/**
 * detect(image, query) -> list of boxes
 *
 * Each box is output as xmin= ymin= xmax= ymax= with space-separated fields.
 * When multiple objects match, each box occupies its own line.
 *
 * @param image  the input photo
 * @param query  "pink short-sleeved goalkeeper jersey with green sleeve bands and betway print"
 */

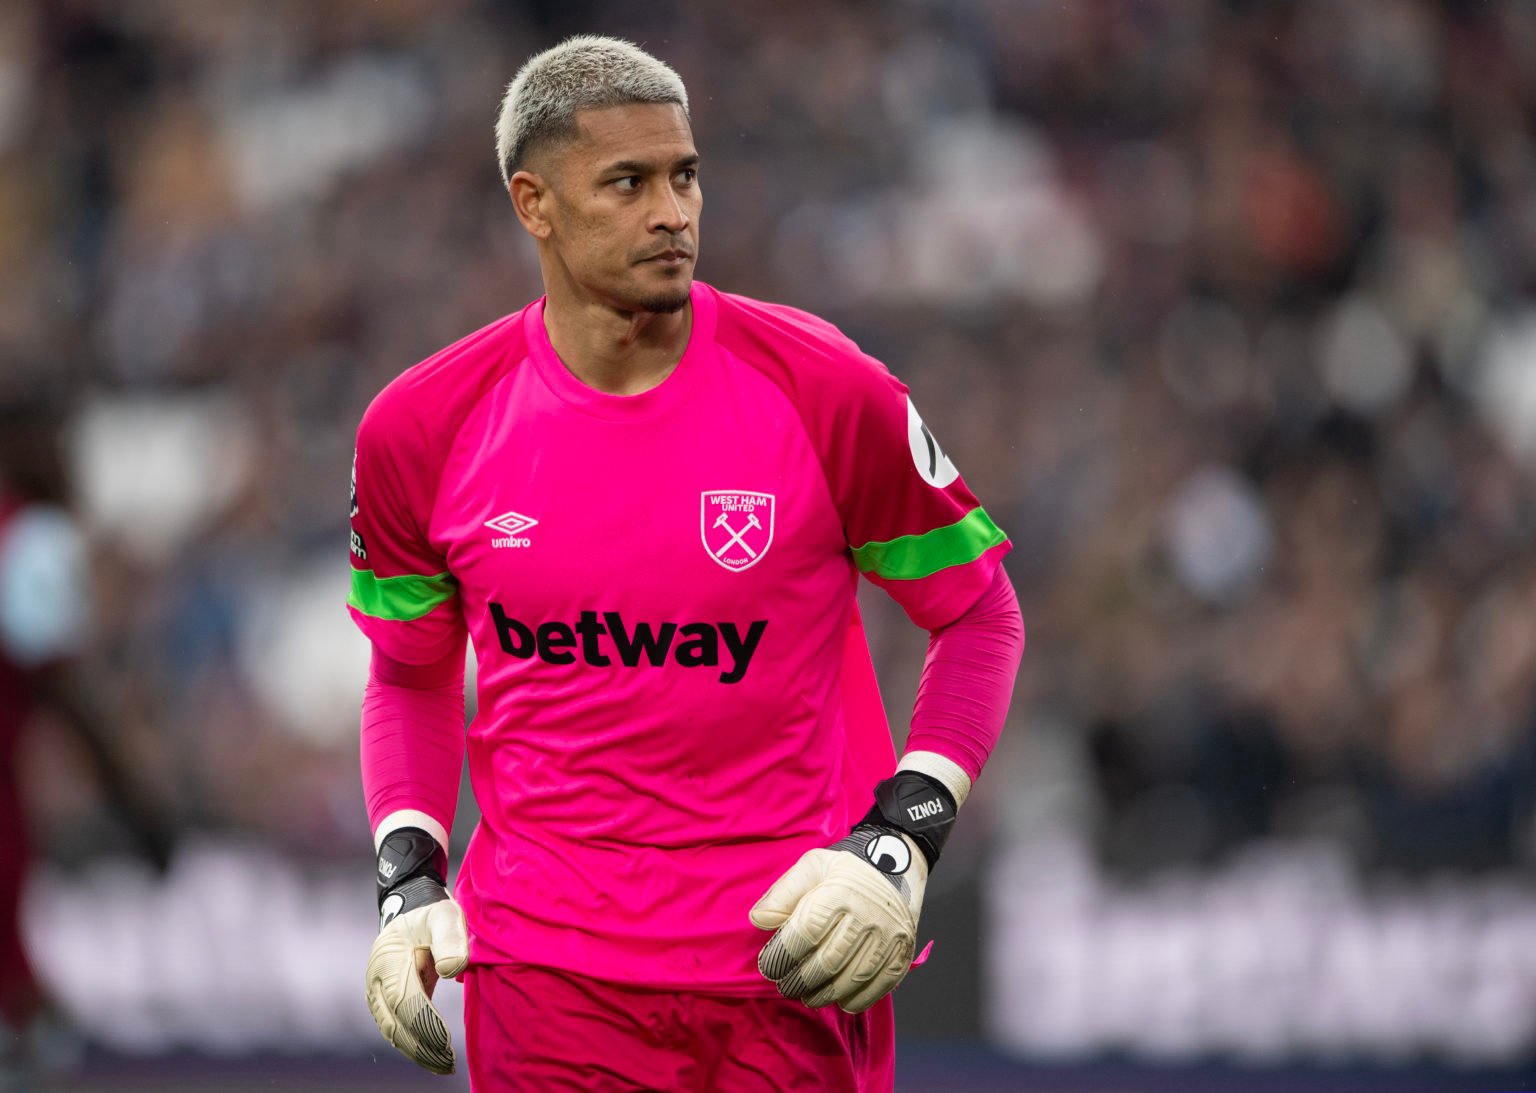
xmin=349 ymin=282 xmax=1009 ymax=993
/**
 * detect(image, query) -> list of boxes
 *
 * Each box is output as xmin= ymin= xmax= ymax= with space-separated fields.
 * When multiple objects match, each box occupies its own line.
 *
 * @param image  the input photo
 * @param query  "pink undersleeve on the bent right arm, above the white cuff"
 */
xmin=906 ymin=566 xmax=1025 ymax=781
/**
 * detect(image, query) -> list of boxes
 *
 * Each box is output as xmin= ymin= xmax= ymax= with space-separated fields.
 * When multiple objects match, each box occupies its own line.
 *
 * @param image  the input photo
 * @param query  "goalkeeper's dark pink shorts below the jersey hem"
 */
xmin=464 ymin=964 xmax=895 ymax=1093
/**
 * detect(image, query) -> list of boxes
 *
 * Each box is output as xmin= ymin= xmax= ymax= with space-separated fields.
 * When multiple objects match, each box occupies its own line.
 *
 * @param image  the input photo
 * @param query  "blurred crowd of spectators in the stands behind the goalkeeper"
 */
xmin=0 ymin=0 xmax=1536 ymax=870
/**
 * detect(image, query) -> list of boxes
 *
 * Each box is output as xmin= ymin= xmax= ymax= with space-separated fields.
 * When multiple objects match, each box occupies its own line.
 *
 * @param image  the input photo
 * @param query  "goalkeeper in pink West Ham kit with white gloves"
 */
xmin=349 ymin=37 xmax=1023 ymax=1090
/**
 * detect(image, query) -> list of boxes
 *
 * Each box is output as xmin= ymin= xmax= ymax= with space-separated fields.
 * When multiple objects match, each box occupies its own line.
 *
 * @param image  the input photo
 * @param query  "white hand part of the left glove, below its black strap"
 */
xmin=367 ymin=878 xmax=470 ymax=1075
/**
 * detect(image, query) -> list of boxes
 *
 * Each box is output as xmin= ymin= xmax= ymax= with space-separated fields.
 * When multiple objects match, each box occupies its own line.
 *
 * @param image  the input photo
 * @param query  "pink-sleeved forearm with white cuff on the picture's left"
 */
xmin=361 ymin=646 xmax=464 ymax=849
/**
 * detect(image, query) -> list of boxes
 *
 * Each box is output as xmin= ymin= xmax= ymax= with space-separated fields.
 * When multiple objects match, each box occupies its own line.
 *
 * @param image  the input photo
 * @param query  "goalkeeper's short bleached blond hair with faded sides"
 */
xmin=496 ymin=34 xmax=688 ymax=184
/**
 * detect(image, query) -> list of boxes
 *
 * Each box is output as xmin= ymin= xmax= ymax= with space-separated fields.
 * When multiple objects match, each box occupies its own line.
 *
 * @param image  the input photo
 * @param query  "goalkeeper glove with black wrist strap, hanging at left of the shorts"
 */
xmin=367 ymin=827 xmax=468 ymax=1075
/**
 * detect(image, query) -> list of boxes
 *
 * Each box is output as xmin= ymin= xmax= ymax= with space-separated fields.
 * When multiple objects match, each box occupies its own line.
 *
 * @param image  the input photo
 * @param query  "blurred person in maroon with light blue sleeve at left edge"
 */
xmin=0 ymin=398 xmax=170 ymax=1088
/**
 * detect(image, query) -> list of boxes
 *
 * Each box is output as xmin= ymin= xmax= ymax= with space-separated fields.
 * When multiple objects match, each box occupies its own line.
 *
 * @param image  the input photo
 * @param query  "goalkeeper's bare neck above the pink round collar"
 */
xmin=544 ymin=292 xmax=693 ymax=395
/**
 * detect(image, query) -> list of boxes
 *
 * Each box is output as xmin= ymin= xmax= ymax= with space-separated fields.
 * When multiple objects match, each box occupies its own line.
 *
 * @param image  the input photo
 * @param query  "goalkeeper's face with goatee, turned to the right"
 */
xmin=535 ymin=104 xmax=703 ymax=312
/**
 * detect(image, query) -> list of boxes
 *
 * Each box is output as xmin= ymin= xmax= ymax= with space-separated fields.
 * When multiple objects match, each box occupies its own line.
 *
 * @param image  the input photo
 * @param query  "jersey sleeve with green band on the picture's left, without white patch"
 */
xmin=347 ymin=398 xmax=464 ymax=665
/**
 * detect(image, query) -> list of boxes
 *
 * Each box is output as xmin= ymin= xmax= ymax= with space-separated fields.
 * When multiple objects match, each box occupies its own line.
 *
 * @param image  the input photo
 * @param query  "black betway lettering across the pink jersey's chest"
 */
xmin=488 ymin=602 xmax=768 ymax=683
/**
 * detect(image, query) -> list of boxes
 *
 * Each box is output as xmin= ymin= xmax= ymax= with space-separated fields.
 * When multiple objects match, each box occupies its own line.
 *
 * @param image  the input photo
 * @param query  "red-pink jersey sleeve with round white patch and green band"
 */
xmin=826 ymin=358 xmax=1011 ymax=629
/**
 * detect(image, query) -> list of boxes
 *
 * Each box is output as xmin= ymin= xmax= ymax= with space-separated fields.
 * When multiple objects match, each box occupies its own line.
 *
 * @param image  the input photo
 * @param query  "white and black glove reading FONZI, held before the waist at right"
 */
xmin=751 ymin=771 xmax=955 ymax=1013
